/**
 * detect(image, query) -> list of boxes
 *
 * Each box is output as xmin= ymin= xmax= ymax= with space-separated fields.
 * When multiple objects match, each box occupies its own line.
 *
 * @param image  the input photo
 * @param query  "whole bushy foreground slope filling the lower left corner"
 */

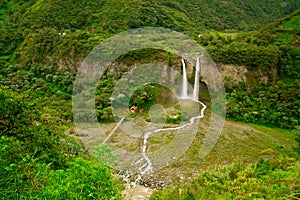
xmin=0 ymin=87 xmax=119 ymax=199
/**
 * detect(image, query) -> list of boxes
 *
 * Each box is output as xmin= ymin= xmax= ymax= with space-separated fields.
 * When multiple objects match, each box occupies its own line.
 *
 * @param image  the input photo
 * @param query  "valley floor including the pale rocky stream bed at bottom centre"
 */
xmin=68 ymin=115 xmax=295 ymax=200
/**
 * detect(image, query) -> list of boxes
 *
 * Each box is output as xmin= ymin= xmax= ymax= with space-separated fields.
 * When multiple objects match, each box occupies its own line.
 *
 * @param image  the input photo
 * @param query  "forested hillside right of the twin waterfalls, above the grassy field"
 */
xmin=199 ymin=10 xmax=300 ymax=129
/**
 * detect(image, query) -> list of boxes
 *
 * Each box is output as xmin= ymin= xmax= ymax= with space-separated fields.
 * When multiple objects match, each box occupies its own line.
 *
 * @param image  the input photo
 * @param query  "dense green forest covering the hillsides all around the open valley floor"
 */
xmin=0 ymin=0 xmax=300 ymax=199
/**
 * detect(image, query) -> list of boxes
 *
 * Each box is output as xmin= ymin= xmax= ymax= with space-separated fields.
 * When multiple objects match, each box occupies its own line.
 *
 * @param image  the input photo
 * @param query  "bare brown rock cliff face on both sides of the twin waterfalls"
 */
xmin=108 ymin=58 xmax=278 ymax=91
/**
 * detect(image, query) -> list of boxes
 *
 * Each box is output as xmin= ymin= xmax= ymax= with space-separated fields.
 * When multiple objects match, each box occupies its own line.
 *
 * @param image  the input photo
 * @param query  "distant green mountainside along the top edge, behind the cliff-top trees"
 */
xmin=2 ymin=0 xmax=300 ymax=32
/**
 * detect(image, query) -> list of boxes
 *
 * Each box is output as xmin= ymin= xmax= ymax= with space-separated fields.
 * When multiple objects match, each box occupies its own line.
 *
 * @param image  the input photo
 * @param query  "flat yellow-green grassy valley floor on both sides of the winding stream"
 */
xmin=83 ymin=111 xmax=297 ymax=186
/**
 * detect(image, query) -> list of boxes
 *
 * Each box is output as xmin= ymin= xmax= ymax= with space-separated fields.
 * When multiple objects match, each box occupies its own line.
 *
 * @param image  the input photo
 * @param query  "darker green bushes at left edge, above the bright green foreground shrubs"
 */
xmin=0 ymin=88 xmax=66 ymax=167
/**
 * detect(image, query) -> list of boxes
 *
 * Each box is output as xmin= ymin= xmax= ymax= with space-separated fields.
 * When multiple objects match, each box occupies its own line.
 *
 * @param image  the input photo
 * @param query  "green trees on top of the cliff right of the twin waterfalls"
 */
xmin=198 ymin=10 xmax=300 ymax=75
